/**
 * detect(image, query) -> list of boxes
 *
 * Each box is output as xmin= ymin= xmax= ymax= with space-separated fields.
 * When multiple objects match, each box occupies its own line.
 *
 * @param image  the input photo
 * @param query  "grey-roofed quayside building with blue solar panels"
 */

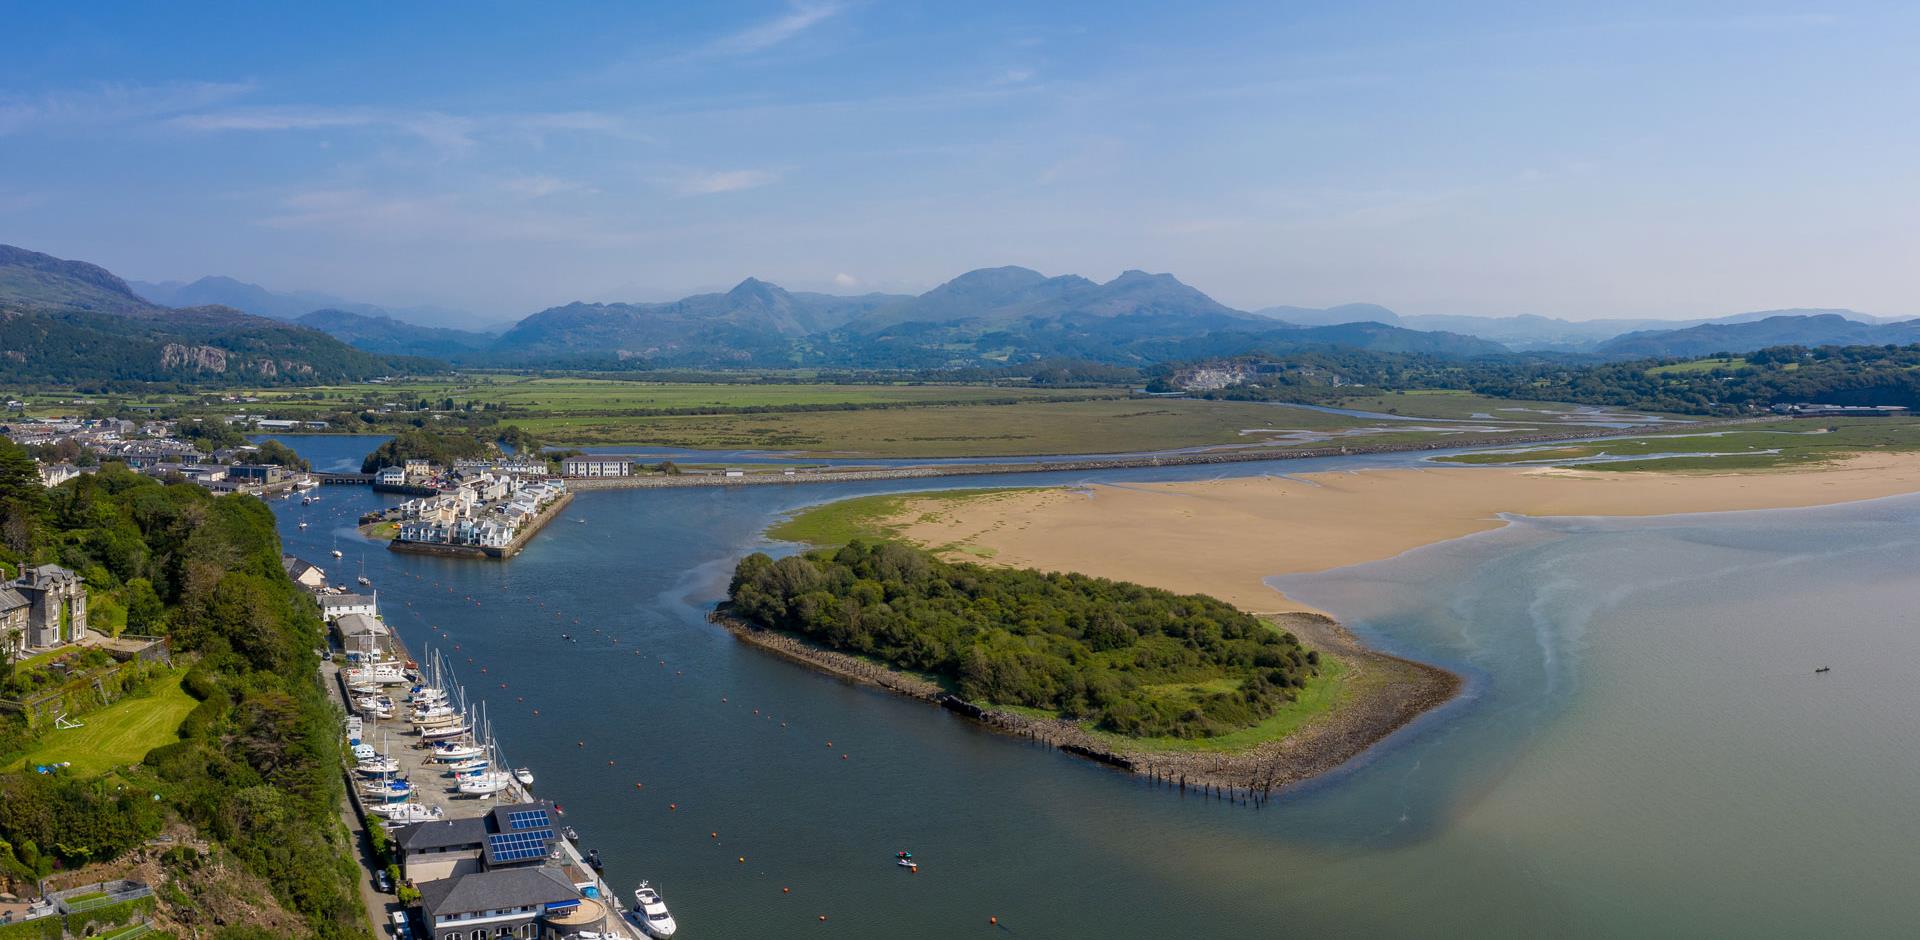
xmin=397 ymin=800 xmax=599 ymax=940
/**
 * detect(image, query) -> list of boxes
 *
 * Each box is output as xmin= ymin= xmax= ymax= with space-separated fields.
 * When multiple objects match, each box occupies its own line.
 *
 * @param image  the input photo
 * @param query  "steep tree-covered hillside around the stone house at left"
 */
xmin=0 ymin=439 xmax=367 ymax=938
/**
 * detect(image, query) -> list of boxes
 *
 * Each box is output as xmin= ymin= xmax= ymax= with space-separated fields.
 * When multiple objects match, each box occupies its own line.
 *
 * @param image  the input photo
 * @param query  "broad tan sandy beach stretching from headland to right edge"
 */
xmin=887 ymin=453 xmax=1920 ymax=614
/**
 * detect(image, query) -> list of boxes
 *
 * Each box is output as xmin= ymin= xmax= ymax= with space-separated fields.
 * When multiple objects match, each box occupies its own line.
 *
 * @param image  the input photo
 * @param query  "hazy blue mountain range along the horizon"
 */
xmin=15 ymin=246 xmax=1920 ymax=380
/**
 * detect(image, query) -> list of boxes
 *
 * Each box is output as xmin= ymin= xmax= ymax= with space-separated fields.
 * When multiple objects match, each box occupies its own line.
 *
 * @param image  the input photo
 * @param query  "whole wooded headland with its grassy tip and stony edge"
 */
xmin=716 ymin=539 xmax=1459 ymax=798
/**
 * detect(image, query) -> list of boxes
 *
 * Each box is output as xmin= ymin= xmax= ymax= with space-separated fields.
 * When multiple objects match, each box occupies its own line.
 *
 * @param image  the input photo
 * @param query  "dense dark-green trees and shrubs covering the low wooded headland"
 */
xmin=728 ymin=541 xmax=1319 ymax=739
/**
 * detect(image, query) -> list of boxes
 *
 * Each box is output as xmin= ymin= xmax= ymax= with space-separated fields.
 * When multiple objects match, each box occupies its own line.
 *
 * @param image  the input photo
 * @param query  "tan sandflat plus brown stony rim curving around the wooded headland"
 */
xmin=729 ymin=453 xmax=1920 ymax=794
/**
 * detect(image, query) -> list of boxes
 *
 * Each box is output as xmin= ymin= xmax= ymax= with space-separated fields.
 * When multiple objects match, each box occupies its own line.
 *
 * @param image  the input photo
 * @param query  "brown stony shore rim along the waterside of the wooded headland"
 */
xmin=707 ymin=602 xmax=1465 ymax=806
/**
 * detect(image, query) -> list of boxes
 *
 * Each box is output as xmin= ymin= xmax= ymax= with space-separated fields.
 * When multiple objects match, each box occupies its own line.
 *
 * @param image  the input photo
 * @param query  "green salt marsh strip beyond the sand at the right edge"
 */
xmin=1440 ymin=418 xmax=1920 ymax=472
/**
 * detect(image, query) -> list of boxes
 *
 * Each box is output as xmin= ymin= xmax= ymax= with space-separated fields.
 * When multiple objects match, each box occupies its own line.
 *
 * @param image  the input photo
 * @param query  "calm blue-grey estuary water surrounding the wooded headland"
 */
xmin=276 ymin=437 xmax=1920 ymax=940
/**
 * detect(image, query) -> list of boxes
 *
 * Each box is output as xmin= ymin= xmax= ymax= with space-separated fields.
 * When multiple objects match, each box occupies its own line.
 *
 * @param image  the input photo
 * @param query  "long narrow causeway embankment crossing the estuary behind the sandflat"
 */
xmin=566 ymin=418 xmax=1780 ymax=491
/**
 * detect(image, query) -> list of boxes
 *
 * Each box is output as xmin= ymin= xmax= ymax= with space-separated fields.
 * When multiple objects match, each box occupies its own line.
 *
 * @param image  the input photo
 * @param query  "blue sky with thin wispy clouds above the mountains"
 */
xmin=0 ymin=0 xmax=1920 ymax=322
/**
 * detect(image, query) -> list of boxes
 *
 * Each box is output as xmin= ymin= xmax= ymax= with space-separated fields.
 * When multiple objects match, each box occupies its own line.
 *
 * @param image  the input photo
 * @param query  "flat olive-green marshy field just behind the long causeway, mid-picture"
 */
xmin=515 ymin=399 xmax=1420 ymax=457
